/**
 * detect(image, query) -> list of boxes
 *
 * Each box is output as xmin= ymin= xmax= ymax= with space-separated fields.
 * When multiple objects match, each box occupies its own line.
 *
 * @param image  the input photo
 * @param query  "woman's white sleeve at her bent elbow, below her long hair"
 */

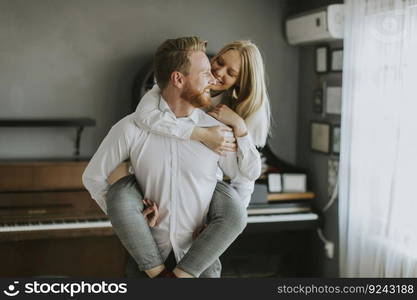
xmin=236 ymin=133 xmax=262 ymax=180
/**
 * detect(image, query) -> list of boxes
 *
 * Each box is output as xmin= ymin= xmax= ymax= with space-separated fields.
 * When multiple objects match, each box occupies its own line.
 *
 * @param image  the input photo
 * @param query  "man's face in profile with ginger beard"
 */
xmin=181 ymin=51 xmax=216 ymax=108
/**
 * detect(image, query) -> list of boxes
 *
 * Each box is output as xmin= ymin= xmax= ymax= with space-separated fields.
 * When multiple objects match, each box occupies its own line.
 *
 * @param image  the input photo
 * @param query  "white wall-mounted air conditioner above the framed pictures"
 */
xmin=285 ymin=4 xmax=344 ymax=45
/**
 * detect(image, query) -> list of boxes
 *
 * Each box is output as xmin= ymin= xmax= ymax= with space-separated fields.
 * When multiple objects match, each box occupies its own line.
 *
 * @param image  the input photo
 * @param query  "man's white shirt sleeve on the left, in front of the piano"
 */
xmin=82 ymin=118 xmax=137 ymax=214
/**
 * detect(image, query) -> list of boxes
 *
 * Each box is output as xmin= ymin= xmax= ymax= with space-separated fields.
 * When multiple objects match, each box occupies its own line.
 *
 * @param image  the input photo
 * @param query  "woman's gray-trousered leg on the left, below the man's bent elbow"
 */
xmin=106 ymin=175 xmax=164 ymax=277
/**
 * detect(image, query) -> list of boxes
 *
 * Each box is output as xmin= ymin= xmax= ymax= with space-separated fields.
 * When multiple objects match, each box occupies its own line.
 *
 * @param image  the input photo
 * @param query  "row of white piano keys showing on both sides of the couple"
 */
xmin=0 ymin=213 xmax=318 ymax=232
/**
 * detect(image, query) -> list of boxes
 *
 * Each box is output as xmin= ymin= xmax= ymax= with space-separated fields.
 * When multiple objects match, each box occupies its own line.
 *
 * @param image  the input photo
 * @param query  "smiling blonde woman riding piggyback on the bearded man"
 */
xmin=108 ymin=41 xmax=270 ymax=277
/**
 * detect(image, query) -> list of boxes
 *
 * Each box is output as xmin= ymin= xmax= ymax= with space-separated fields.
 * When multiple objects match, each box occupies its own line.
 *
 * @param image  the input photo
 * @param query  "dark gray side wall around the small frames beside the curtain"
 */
xmin=287 ymin=0 xmax=343 ymax=277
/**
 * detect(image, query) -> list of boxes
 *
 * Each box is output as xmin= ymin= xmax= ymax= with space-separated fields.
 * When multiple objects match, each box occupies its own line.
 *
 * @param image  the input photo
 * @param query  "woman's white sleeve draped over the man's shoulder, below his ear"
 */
xmin=135 ymin=85 xmax=194 ymax=140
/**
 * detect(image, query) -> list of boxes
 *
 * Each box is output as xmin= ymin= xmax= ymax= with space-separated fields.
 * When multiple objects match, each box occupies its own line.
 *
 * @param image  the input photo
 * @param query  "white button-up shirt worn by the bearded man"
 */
xmin=82 ymin=93 xmax=254 ymax=261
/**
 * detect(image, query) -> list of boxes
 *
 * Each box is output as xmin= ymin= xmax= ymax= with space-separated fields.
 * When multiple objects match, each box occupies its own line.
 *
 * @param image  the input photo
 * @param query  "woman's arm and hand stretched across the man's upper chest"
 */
xmin=135 ymin=85 xmax=236 ymax=155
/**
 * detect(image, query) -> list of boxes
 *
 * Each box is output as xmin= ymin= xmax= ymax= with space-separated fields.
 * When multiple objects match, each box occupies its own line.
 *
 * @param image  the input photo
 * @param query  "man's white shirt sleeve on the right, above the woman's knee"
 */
xmin=219 ymin=152 xmax=255 ymax=207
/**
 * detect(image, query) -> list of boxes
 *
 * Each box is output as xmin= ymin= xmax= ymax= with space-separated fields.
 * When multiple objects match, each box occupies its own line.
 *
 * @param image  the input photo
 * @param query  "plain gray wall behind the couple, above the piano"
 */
xmin=0 ymin=0 xmax=298 ymax=162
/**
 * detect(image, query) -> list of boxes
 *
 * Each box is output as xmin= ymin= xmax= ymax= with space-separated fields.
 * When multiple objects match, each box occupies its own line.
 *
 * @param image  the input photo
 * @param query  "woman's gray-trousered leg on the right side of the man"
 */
xmin=177 ymin=181 xmax=247 ymax=277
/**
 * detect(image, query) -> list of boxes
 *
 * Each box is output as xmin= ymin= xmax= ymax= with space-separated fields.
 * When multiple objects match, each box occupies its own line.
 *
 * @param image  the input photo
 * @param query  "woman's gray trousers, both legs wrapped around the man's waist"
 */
xmin=106 ymin=175 xmax=247 ymax=278
